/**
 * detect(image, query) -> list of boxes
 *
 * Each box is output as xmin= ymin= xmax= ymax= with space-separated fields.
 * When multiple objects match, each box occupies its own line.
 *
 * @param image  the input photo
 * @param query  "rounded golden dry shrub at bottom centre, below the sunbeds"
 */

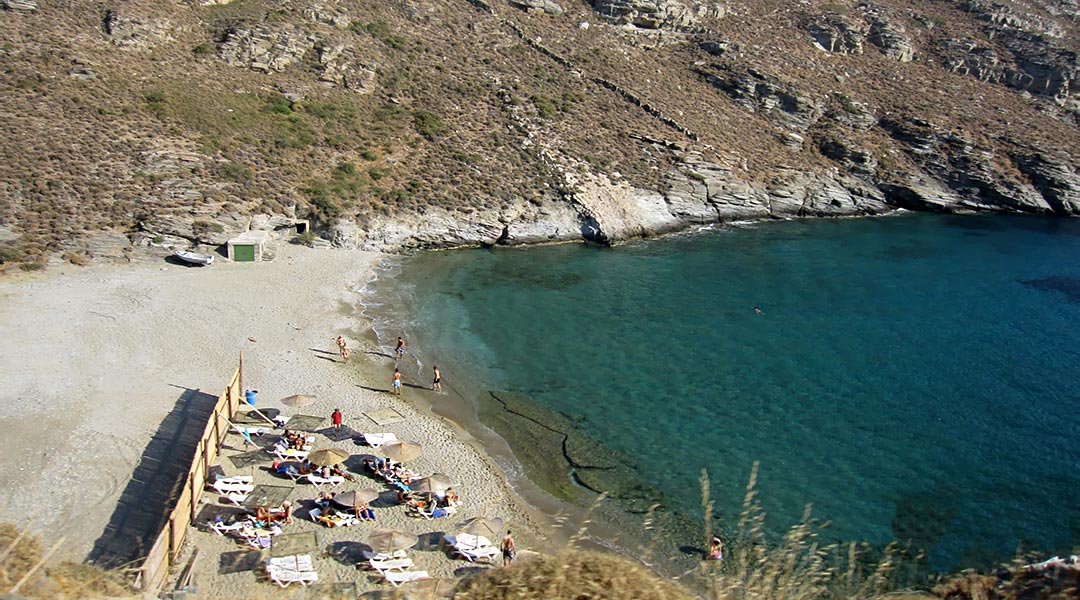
xmin=454 ymin=549 xmax=693 ymax=600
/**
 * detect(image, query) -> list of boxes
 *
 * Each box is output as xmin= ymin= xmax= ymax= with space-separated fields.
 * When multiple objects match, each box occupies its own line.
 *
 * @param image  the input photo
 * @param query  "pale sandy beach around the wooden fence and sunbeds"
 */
xmin=0 ymin=245 xmax=552 ymax=598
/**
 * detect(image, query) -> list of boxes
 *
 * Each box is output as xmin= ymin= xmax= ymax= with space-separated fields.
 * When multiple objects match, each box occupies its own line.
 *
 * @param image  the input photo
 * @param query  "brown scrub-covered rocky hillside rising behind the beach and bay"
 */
xmin=0 ymin=0 xmax=1080 ymax=268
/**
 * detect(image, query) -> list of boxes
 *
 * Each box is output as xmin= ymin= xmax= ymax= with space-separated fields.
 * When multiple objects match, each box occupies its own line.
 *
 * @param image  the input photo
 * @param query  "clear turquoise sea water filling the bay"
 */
xmin=365 ymin=215 xmax=1080 ymax=570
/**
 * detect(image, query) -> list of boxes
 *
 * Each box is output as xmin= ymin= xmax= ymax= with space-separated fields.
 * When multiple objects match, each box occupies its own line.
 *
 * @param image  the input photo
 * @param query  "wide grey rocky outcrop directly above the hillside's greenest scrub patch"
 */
xmin=218 ymin=25 xmax=315 ymax=72
